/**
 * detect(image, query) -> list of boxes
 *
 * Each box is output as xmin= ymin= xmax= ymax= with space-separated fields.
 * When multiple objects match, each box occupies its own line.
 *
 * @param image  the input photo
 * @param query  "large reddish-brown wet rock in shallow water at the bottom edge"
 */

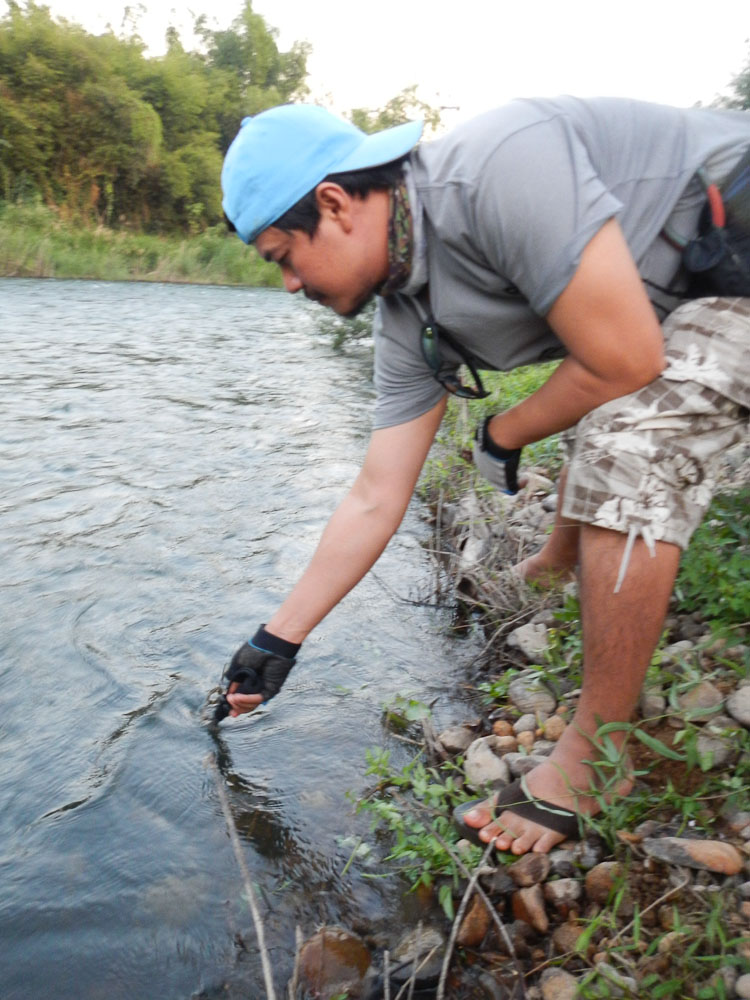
xmin=299 ymin=927 xmax=371 ymax=997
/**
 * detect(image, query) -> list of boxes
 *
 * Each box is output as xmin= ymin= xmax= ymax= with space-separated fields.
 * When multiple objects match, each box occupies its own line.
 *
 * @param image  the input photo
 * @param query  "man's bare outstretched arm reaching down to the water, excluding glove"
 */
xmin=228 ymin=400 xmax=445 ymax=715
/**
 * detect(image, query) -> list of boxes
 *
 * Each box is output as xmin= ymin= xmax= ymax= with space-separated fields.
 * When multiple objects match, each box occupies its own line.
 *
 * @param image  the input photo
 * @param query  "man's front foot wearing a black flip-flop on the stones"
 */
xmin=462 ymin=726 xmax=633 ymax=854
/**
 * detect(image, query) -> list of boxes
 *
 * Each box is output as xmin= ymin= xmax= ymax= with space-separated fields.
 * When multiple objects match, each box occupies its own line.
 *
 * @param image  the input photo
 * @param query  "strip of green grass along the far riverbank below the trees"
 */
xmin=0 ymin=203 xmax=280 ymax=287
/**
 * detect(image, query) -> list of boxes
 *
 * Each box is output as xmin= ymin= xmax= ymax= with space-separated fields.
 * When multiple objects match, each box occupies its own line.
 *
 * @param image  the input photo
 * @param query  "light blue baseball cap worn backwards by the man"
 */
xmin=221 ymin=104 xmax=422 ymax=243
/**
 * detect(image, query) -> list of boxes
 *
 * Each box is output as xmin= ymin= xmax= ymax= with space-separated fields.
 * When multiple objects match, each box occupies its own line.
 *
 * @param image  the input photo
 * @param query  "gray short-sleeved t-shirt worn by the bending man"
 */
xmin=374 ymin=97 xmax=750 ymax=427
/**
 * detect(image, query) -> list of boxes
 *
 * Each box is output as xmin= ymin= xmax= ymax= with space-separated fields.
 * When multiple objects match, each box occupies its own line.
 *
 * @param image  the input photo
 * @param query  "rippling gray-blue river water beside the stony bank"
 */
xmin=0 ymin=279 xmax=476 ymax=1000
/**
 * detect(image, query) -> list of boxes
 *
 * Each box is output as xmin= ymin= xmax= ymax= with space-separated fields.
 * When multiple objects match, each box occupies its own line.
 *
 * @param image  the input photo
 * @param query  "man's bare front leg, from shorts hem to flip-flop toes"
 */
xmin=465 ymin=524 xmax=680 ymax=854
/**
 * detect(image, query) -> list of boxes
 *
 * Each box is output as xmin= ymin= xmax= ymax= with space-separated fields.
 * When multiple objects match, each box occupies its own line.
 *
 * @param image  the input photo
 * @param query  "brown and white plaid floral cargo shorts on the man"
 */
xmin=562 ymin=298 xmax=750 ymax=550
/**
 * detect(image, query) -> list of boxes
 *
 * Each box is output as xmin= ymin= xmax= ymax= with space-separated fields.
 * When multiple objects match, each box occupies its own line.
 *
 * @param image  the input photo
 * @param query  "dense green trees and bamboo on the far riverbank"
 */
xmin=0 ymin=0 xmax=308 ymax=231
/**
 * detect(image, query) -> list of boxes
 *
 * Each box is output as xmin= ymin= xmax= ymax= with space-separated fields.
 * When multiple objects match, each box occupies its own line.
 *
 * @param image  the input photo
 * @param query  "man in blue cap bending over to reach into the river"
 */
xmin=222 ymin=98 xmax=750 ymax=854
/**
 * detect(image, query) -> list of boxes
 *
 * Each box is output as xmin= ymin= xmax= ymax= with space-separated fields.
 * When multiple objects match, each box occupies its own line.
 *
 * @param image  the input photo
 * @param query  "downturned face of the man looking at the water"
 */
xmin=255 ymin=185 xmax=388 ymax=316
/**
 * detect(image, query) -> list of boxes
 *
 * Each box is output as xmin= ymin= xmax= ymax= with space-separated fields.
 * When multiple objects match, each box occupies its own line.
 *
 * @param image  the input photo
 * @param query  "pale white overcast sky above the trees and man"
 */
xmin=0 ymin=0 xmax=750 ymax=124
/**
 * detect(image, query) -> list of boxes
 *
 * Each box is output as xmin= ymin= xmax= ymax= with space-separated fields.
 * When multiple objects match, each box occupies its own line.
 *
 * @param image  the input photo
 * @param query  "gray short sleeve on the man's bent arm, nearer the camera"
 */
xmin=474 ymin=115 xmax=622 ymax=316
